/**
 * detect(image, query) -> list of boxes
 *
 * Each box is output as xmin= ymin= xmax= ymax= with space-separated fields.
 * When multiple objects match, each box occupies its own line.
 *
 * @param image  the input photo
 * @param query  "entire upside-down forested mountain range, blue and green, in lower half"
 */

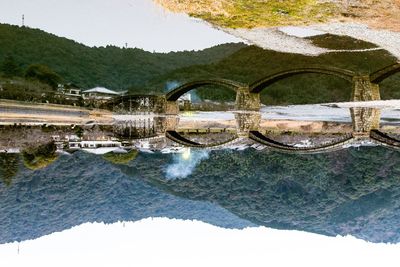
xmin=0 ymin=147 xmax=400 ymax=243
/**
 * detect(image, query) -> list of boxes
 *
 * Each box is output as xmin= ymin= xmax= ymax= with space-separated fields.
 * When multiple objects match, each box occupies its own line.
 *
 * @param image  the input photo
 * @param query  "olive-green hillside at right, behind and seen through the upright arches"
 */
xmin=151 ymin=38 xmax=400 ymax=104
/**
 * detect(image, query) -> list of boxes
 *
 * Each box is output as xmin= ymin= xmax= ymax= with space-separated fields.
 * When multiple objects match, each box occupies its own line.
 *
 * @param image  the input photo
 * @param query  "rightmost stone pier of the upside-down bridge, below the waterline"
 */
xmin=350 ymin=107 xmax=381 ymax=136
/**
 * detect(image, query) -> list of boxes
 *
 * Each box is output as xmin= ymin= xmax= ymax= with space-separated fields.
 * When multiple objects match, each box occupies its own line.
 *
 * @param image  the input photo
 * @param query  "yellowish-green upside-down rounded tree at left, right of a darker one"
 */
xmin=22 ymin=142 xmax=58 ymax=170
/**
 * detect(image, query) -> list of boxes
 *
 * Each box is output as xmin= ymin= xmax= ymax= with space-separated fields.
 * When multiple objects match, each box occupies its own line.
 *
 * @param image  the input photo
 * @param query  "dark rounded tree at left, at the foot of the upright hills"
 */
xmin=25 ymin=64 xmax=62 ymax=89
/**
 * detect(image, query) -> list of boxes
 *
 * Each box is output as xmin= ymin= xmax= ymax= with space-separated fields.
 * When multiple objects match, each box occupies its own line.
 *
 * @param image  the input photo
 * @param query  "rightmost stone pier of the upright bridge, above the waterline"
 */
xmin=351 ymin=75 xmax=381 ymax=101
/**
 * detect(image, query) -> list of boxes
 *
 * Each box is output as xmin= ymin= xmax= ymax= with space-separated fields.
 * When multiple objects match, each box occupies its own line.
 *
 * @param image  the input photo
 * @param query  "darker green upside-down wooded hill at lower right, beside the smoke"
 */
xmin=126 ymin=147 xmax=400 ymax=243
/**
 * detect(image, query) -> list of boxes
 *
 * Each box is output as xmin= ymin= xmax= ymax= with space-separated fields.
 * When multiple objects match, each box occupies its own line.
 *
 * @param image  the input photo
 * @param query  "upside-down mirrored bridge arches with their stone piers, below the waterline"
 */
xmin=159 ymin=108 xmax=400 ymax=154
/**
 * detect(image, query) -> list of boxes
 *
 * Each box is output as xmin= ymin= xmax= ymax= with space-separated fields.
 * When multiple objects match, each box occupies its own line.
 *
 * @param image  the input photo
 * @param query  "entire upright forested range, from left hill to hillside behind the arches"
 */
xmin=0 ymin=24 xmax=400 ymax=104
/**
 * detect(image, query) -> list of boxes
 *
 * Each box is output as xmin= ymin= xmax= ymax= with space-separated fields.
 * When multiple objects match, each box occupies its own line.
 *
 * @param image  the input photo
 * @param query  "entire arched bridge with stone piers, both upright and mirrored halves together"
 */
xmin=110 ymin=63 xmax=400 ymax=153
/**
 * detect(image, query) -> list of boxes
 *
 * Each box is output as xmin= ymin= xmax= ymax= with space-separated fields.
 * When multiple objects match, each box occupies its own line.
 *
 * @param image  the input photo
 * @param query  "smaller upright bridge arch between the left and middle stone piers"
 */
xmin=165 ymin=79 xmax=246 ymax=101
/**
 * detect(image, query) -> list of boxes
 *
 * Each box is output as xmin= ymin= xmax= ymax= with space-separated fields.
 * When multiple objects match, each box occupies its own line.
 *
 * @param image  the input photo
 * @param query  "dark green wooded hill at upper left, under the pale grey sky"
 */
xmin=0 ymin=24 xmax=244 ymax=90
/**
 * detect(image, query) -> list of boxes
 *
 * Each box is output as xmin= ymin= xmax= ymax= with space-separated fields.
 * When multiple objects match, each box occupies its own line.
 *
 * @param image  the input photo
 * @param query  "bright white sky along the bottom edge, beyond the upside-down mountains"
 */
xmin=0 ymin=218 xmax=400 ymax=267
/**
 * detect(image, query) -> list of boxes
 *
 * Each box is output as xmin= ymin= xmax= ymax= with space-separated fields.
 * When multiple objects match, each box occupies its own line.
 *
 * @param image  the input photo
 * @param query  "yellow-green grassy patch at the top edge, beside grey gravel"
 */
xmin=157 ymin=0 xmax=338 ymax=28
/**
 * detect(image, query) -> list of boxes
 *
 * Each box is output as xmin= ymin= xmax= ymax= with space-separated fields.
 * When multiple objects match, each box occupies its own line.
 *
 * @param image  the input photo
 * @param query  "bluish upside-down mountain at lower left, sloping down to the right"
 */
xmin=0 ymin=153 xmax=253 ymax=243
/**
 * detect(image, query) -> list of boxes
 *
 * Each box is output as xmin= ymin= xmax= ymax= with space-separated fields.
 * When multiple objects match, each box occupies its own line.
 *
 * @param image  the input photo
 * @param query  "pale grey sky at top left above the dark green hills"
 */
xmin=0 ymin=0 xmax=241 ymax=52
